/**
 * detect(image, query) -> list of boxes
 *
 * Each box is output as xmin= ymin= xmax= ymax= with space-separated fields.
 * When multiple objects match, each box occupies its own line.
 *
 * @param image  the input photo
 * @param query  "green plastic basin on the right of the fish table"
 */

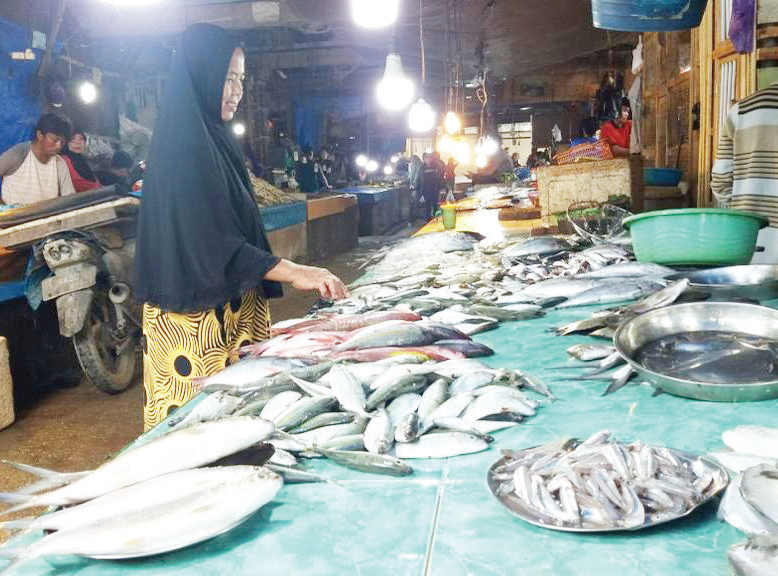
xmin=624 ymin=208 xmax=769 ymax=266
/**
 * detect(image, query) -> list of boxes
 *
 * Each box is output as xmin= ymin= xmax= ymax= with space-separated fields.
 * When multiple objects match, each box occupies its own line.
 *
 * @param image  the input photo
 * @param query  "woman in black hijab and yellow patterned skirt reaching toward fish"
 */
xmin=135 ymin=24 xmax=347 ymax=429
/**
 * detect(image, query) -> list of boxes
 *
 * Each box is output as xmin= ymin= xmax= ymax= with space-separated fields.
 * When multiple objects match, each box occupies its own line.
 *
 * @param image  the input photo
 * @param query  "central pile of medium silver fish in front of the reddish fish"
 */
xmin=186 ymin=349 xmax=553 ymax=480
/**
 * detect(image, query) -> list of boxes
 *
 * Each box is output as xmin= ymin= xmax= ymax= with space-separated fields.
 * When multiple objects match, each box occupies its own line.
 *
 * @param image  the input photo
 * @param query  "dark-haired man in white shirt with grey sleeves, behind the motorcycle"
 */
xmin=0 ymin=113 xmax=76 ymax=205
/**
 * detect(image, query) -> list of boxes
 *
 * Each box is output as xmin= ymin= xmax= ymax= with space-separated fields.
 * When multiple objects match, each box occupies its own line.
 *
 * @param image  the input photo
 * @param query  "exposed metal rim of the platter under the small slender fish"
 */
xmin=486 ymin=446 xmax=729 ymax=534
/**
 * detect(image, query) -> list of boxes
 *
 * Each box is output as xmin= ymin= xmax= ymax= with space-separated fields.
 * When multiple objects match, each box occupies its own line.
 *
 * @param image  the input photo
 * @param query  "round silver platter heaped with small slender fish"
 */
xmin=487 ymin=433 xmax=729 ymax=533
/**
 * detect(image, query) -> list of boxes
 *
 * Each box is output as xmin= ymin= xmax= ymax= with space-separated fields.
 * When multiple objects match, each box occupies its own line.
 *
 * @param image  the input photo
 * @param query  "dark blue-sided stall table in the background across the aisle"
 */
xmin=339 ymin=186 xmax=411 ymax=236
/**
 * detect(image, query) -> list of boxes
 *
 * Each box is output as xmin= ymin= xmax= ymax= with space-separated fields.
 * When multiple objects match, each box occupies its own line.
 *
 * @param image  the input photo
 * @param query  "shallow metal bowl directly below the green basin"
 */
xmin=669 ymin=264 xmax=778 ymax=300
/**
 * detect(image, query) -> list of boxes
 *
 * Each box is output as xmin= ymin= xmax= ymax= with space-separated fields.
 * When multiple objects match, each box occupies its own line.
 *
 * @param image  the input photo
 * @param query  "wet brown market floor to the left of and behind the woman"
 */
xmin=0 ymin=222 xmax=423 ymax=543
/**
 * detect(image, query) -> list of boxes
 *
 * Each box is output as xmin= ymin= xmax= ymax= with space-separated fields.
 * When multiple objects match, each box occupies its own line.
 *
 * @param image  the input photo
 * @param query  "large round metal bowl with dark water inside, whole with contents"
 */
xmin=613 ymin=302 xmax=778 ymax=402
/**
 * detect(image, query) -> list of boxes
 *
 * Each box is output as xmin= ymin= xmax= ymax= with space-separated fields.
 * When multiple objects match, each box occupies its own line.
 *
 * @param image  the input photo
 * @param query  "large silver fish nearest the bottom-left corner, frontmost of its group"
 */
xmin=0 ymin=466 xmax=283 ymax=564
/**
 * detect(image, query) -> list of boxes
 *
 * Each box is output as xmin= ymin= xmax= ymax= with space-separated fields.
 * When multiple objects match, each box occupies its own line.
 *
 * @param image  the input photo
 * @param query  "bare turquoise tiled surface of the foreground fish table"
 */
xmin=6 ymin=301 xmax=778 ymax=576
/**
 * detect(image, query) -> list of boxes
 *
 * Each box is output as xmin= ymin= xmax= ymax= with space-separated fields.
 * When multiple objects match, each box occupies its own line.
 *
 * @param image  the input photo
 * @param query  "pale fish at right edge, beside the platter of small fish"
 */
xmin=711 ymin=426 xmax=778 ymax=576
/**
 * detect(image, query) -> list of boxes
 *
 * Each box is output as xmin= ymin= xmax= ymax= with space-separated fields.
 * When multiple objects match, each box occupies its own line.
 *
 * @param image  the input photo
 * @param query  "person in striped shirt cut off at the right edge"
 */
xmin=710 ymin=82 xmax=778 ymax=264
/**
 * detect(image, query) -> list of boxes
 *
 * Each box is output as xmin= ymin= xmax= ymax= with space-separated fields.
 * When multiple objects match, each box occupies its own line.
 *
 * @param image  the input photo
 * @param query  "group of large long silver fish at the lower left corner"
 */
xmin=0 ymin=417 xmax=283 ymax=564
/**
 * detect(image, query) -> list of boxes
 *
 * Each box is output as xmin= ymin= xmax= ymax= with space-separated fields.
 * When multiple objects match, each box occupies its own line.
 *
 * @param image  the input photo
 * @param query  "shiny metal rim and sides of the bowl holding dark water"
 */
xmin=613 ymin=302 xmax=778 ymax=402
